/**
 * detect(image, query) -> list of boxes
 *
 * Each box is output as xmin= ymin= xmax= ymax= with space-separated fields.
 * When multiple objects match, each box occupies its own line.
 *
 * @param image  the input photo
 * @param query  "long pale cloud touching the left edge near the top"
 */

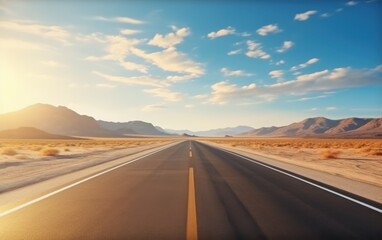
xmin=0 ymin=21 xmax=71 ymax=45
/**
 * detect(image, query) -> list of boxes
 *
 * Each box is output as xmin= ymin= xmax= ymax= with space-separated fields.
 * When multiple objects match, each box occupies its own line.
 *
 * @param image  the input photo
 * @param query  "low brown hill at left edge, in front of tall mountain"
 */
xmin=0 ymin=127 xmax=80 ymax=139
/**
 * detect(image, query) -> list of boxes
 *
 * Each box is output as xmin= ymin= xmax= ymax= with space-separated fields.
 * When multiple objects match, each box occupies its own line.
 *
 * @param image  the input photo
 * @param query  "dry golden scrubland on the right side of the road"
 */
xmin=203 ymin=138 xmax=382 ymax=187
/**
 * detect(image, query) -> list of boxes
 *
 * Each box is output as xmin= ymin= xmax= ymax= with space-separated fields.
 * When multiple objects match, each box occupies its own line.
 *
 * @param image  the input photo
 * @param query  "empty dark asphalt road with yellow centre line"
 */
xmin=0 ymin=141 xmax=382 ymax=240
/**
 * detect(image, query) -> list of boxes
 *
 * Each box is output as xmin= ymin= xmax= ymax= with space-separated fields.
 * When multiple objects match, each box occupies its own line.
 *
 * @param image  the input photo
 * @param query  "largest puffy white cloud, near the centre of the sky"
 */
xmin=132 ymin=47 xmax=204 ymax=76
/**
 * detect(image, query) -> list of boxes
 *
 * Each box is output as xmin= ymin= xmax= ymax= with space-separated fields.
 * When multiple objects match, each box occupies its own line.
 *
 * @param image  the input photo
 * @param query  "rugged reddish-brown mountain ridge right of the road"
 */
xmin=242 ymin=117 xmax=382 ymax=137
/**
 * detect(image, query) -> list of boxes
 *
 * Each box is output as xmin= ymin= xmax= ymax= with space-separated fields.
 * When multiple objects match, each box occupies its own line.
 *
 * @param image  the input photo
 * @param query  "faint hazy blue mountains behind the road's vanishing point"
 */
xmin=165 ymin=126 xmax=254 ymax=137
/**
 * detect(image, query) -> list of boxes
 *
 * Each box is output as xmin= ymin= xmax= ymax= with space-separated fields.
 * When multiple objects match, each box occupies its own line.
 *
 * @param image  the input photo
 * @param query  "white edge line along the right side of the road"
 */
xmin=209 ymin=142 xmax=382 ymax=213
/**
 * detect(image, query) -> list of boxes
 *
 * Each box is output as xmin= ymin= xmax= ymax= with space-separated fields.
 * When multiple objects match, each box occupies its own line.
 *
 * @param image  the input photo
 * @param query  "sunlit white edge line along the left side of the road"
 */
xmin=0 ymin=143 xmax=171 ymax=218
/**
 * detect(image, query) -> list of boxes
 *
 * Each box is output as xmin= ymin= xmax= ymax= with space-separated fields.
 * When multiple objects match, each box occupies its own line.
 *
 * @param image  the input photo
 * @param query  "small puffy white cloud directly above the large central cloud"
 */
xmin=148 ymin=27 xmax=190 ymax=48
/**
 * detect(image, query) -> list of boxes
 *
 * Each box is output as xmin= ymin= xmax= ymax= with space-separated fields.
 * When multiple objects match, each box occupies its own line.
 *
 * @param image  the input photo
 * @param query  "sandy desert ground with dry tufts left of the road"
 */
xmin=0 ymin=138 xmax=173 ymax=193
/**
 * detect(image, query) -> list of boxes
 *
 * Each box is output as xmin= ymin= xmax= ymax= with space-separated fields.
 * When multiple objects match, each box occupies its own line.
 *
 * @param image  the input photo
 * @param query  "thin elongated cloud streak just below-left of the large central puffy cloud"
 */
xmin=93 ymin=71 xmax=164 ymax=87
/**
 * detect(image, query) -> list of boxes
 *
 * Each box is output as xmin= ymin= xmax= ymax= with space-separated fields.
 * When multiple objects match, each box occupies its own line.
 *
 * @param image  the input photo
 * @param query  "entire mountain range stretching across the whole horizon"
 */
xmin=0 ymin=104 xmax=382 ymax=139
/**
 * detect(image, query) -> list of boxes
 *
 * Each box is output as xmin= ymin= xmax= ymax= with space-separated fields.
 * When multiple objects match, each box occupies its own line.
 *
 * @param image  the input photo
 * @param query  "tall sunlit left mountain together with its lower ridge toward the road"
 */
xmin=0 ymin=103 xmax=166 ymax=137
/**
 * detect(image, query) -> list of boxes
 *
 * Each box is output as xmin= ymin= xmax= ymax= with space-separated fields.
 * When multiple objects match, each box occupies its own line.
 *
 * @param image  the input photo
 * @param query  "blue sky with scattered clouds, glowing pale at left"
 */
xmin=0 ymin=0 xmax=382 ymax=131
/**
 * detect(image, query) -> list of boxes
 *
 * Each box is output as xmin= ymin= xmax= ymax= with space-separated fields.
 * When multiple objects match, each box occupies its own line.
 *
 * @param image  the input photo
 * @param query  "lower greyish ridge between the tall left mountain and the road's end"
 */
xmin=97 ymin=120 xmax=168 ymax=135
